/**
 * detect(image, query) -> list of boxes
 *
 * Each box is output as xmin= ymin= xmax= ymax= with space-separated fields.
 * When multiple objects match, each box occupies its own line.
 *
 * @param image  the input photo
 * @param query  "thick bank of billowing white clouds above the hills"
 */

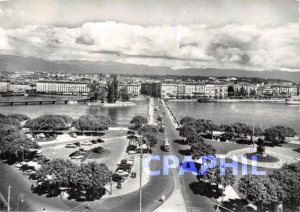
xmin=0 ymin=22 xmax=299 ymax=71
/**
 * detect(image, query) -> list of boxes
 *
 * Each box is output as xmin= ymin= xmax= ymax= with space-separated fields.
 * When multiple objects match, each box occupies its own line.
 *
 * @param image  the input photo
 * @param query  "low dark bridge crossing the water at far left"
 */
xmin=0 ymin=99 xmax=88 ymax=106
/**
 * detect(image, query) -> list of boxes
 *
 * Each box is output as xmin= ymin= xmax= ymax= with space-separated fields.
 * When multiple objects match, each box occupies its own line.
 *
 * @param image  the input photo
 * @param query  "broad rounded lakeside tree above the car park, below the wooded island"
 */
xmin=72 ymin=115 xmax=110 ymax=133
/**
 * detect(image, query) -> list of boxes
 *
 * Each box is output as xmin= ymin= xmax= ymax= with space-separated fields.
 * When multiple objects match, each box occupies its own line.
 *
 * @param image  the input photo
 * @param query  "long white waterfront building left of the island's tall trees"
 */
xmin=36 ymin=81 xmax=90 ymax=95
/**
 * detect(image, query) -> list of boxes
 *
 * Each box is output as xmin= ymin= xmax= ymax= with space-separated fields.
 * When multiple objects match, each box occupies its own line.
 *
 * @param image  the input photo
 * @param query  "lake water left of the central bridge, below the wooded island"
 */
xmin=0 ymin=97 xmax=148 ymax=126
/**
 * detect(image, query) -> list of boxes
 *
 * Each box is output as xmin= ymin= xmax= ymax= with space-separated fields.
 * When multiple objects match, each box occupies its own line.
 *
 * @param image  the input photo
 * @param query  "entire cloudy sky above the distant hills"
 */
xmin=0 ymin=0 xmax=300 ymax=71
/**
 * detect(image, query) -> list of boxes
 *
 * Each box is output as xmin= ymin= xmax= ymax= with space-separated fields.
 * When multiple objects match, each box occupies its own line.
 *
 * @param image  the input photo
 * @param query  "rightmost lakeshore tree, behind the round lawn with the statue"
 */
xmin=264 ymin=125 xmax=296 ymax=145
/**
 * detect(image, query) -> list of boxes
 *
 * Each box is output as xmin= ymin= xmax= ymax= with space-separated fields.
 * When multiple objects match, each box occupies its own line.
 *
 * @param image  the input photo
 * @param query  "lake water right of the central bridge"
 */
xmin=167 ymin=102 xmax=300 ymax=135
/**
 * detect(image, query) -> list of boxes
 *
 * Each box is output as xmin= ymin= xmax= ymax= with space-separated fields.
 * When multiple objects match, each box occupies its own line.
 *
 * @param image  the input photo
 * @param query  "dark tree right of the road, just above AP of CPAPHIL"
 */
xmin=191 ymin=142 xmax=216 ymax=159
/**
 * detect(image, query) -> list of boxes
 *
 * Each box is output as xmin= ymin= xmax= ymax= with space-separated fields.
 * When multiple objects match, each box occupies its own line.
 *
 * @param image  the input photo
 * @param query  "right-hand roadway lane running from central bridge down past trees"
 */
xmin=160 ymin=99 xmax=215 ymax=212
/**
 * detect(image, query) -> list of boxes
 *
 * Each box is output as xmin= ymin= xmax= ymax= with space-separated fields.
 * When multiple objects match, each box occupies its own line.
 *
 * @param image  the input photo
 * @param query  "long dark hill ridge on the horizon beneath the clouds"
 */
xmin=0 ymin=55 xmax=300 ymax=83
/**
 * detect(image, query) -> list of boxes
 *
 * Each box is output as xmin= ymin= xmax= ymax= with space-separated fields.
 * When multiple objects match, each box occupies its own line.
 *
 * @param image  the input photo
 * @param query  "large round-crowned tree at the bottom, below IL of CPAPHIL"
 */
xmin=238 ymin=175 xmax=282 ymax=211
